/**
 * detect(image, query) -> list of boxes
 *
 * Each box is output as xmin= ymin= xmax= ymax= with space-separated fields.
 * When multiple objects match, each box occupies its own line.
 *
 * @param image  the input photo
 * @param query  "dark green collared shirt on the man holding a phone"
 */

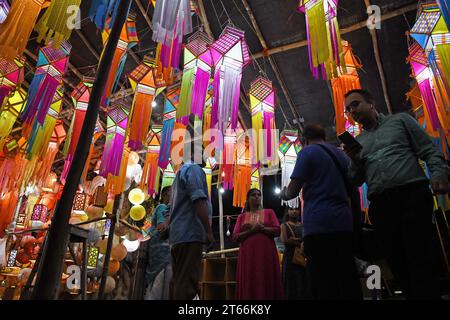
xmin=352 ymin=113 xmax=448 ymax=199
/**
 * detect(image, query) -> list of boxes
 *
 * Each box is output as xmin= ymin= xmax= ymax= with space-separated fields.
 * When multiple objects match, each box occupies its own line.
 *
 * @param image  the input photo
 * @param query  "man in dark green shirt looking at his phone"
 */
xmin=345 ymin=90 xmax=448 ymax=299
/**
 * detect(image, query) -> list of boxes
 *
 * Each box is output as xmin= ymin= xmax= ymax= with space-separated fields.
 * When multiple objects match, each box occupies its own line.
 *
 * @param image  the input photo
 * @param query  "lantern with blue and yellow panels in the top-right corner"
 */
xmin=410 ymin=2 xmax=450 ymax=85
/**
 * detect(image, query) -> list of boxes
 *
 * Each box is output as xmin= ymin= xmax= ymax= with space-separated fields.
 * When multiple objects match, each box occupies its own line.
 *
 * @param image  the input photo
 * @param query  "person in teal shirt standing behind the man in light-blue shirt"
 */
xmin=145 ymin=186 xmax=172 ymax=300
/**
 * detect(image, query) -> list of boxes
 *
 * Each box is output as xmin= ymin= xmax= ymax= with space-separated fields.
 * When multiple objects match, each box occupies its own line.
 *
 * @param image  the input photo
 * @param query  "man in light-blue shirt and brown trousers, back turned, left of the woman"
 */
xmin=169 ymin=138 xmax=214 ymax=300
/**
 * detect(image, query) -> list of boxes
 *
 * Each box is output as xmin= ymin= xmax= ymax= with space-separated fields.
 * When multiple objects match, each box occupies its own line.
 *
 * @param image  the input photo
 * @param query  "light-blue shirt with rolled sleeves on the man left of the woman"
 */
xmin=169 ymin=162 xmax=212 ymax=246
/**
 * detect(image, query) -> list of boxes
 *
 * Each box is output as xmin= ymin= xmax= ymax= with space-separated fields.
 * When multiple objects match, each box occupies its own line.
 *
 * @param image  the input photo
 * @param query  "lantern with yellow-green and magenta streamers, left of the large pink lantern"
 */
xmin=177 ymin=31 xmax=214 ymax=124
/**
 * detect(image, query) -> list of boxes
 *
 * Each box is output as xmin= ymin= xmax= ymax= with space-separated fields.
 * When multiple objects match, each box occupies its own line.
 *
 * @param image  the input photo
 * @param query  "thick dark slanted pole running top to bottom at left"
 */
xmin=35 ymin=0 xmax=131 ymax=300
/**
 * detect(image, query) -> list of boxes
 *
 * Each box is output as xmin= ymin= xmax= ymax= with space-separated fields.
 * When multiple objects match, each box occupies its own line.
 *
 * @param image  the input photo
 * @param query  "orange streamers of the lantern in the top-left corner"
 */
xmin=0 ymin=0 xmax=47 ymax=62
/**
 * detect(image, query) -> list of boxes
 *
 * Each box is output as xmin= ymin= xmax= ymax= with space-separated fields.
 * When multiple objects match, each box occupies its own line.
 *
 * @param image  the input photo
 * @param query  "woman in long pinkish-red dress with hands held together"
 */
xmin=233 ymin=189 xmax=284 ymax=300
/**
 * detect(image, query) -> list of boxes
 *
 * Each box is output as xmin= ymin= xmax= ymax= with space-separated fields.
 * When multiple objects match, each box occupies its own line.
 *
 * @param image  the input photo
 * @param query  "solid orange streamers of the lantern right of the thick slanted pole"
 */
xmin=128 ymin=92 xmax=153 ymax=151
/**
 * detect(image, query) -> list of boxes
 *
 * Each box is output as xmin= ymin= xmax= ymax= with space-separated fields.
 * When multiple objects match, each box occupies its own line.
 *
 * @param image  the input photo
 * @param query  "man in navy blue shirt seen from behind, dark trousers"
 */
xmin=281 ymin=125 xmax=362 ymax=299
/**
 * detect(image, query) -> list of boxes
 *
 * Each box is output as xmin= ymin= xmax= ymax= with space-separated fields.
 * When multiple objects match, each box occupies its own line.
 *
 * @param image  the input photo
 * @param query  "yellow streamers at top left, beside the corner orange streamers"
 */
xmin=35 ymin=0 xmax=81 ymax=49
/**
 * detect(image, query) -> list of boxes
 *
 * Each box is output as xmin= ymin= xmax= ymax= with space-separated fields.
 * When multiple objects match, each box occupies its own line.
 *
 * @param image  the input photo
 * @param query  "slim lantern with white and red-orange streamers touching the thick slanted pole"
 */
xmin=61 ymin=78 xmax=93 ymax=182
